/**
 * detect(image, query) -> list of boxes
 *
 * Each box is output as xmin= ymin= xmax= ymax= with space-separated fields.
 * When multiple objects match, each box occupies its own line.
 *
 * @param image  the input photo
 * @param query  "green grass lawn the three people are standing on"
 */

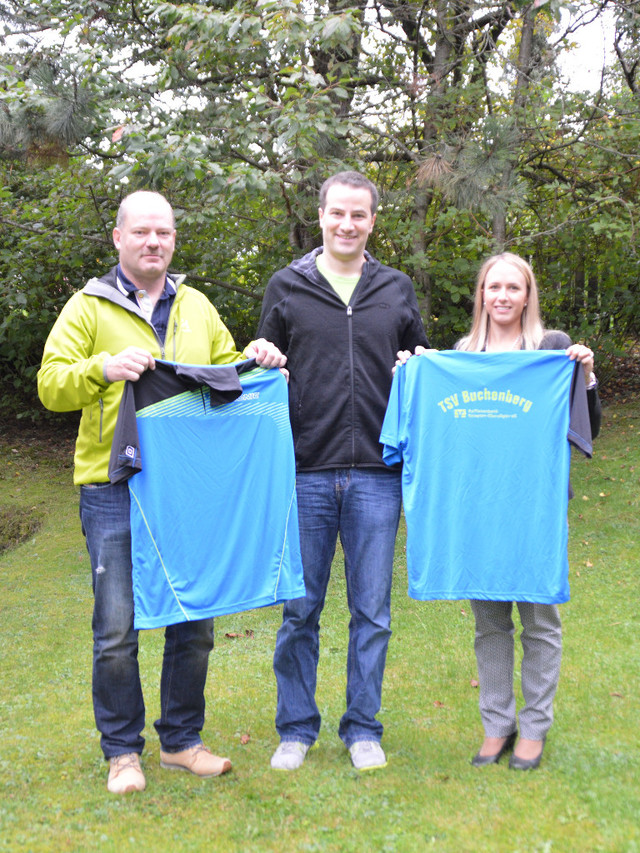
xmin=0 ymin=402 xmax=640 ymax=853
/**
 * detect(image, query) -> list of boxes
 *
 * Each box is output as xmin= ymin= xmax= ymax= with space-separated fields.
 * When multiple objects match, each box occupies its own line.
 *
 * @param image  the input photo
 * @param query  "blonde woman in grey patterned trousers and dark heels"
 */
xmin=456 ymin=252 xmax=600 ymax=770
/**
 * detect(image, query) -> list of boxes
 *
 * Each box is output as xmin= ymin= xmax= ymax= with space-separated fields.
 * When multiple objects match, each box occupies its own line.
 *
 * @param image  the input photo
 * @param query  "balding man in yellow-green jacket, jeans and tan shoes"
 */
xmin=38 ymin=191 xmax=286 ymax=793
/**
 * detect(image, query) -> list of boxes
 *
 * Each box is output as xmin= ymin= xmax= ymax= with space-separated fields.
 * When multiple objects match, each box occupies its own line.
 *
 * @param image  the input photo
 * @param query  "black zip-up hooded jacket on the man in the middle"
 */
xmin=258 ymin=249 xmax=429 ymax=471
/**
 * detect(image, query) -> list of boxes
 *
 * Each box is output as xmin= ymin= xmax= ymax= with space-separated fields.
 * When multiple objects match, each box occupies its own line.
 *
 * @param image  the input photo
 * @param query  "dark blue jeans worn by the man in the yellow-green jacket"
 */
xmin=80 ymin=483 xmax=213 ymax=758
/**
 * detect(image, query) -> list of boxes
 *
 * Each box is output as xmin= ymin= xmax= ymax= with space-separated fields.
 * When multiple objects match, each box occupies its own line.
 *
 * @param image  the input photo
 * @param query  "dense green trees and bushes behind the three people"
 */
xmin=0 ymin=0 xmax=640 ymax=417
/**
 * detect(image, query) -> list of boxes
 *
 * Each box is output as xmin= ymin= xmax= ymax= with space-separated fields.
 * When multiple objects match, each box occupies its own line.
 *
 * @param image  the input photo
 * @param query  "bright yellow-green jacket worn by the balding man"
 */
xmin=38 ymin=267 xmax=244 ymax=485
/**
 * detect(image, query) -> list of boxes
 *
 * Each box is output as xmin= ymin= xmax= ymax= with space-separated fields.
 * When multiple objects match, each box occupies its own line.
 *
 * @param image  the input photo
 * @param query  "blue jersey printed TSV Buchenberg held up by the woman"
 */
xmin=380 ymin=350 xmax=591 ymax=604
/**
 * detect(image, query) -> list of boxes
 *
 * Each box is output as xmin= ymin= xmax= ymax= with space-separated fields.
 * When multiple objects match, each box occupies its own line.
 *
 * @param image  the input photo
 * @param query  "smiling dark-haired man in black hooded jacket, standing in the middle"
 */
xmin=259 ymin=172 xmax=429 ymax=770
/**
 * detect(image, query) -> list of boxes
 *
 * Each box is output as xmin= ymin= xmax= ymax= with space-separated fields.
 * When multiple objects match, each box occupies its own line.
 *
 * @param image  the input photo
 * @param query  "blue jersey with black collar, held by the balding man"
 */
xmin=110 ymin=361 xmax=305 ymax=628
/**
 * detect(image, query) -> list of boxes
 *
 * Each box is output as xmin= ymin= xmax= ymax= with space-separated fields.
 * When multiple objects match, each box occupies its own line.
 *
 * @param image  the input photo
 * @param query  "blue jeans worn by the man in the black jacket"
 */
xmin=273 ymin=468 xmax=401 ymax=747
